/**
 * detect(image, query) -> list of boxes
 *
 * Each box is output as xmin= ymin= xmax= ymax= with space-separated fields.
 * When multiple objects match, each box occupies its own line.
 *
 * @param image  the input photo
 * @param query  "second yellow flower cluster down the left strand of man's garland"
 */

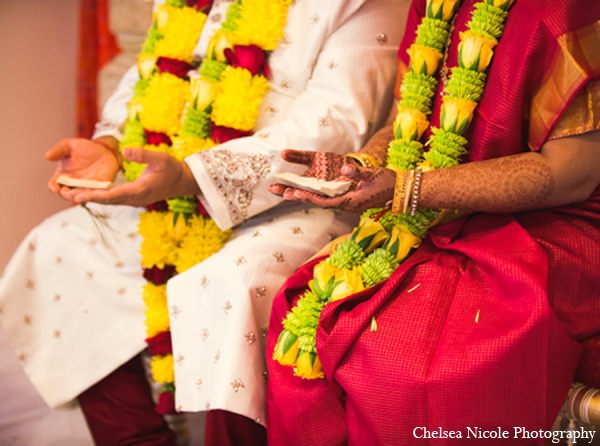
xmin=139 ymin=73 xmax=190 ymax=135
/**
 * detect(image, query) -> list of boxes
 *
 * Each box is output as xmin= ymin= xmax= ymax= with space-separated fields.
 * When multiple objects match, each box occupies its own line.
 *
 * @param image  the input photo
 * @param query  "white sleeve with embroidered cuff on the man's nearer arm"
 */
xmin=186 ymin=0 xmax=401 ymax=229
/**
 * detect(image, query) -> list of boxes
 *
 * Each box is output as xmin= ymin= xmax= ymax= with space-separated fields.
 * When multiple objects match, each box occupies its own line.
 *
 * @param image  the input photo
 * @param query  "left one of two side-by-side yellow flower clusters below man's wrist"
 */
xmin=138 ymin=212 xmax=177 ymax=268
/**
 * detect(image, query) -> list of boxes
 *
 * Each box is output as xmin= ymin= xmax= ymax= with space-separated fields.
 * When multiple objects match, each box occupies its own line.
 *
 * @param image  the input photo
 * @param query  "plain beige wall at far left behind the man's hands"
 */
xmin=0 ymin=0 xmax=79 ymax=275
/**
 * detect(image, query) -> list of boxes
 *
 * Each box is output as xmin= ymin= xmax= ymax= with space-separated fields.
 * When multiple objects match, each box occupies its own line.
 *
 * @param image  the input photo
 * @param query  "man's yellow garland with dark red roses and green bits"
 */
xmin=120 ymin=0 xmax=291 ymax=414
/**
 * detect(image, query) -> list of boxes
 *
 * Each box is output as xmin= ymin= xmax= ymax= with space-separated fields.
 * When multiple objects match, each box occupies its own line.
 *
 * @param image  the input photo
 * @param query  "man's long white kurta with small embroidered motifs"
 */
xmin=0 ymin=0 xmax=407 ymax=422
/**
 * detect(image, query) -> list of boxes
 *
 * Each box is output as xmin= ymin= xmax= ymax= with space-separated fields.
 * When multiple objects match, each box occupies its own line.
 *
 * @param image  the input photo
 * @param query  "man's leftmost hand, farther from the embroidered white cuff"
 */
xmin=46 ymin=138 xmax=120 ymax=195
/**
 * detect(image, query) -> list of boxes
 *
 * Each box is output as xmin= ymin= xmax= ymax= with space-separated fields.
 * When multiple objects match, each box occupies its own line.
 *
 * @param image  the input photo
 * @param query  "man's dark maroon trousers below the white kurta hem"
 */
xmin=78 ymin=356 xmax=267 ymax=446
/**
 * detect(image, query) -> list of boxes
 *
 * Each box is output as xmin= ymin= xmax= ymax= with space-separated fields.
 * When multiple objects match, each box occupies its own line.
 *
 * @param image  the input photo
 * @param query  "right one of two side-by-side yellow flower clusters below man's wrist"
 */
xmin=174 ymin=215 xmax=231 ymax=273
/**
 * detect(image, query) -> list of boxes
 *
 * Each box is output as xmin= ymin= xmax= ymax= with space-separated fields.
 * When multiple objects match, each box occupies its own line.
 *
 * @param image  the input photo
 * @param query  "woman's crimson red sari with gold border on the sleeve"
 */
xmin=267 ymin=0 xmax=600 ymax=446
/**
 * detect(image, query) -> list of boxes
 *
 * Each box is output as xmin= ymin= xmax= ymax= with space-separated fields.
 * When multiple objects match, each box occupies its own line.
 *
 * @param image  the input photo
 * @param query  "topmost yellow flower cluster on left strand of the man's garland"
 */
xmin=154 ymin=5 xmax=206 ymax=63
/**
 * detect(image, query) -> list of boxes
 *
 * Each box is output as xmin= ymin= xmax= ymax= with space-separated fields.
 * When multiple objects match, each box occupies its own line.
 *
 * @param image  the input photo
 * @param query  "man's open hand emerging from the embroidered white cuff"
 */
xmin=62 ymin=149 xmax=200 ymax=206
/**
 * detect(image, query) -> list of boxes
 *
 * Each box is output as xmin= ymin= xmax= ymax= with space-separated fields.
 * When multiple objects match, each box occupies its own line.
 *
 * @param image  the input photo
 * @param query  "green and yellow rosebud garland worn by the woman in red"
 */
xmin=273 ymin=0 xmax=514 ymax=379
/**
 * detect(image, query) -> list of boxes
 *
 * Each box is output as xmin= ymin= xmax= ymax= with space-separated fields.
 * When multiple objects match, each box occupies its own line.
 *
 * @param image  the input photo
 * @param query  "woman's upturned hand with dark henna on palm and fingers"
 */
xmin=269 ymin=150 xmax=396 ymax=212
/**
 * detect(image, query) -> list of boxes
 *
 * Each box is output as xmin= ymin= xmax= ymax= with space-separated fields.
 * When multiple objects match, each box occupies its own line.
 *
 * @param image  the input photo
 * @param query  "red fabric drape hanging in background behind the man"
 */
xmin=77 ymin=0 xmax=121 ymax=138
